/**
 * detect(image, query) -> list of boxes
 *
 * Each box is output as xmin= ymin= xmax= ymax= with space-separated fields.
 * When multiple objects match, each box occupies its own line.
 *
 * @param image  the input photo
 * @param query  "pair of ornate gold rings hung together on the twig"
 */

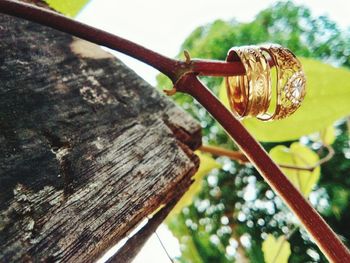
xmin=226 ymin=44 xmax=305 ymax=121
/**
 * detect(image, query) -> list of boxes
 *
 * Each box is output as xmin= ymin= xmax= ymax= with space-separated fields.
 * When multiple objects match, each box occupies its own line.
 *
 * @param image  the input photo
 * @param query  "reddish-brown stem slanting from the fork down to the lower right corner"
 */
xmin=176 ymin=74 xmax=350 ymax=262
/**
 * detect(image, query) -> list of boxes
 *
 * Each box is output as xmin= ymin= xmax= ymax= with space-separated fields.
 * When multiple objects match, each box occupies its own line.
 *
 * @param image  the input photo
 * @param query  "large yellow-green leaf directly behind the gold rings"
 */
xmin=243 ymin=59 xmax=350 ymax=142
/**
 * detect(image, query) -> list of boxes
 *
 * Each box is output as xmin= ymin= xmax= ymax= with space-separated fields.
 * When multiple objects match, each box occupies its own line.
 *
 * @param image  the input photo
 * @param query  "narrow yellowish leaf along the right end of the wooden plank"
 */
xmin=171 ymin=151 xmax=221 ymax=215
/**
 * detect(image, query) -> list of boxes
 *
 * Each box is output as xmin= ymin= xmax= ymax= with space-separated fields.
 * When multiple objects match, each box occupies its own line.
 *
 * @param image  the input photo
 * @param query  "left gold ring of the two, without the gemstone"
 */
xmin=226 ymin=46 xmax=271 ymax=118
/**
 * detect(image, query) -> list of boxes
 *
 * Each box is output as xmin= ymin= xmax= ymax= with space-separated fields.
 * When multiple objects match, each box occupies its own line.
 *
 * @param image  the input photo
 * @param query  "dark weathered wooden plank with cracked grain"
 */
xmin=0 ymin=14 xmax=201 ymax=262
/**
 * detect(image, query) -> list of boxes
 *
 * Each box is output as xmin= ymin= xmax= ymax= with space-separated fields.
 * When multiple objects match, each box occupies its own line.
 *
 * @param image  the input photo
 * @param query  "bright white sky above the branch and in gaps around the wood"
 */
xmin=78 ymin=0 xmax=350 ymax=263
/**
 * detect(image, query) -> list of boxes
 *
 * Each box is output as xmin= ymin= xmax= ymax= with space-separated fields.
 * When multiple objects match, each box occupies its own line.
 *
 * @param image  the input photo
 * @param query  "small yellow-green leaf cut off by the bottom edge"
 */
xmin=262 ymin=234 xmax=291 ymax=263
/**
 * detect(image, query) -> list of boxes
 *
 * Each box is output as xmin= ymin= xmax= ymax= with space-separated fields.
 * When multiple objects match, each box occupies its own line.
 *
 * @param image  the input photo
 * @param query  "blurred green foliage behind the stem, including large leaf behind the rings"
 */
xmin=157 ymin=1 xmax=350 ymax=262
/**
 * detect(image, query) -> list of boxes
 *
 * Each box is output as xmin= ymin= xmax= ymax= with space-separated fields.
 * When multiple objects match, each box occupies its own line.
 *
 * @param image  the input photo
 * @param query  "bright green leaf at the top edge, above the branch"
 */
xmin=45 ymin=0 xmax=90 ymax=17
